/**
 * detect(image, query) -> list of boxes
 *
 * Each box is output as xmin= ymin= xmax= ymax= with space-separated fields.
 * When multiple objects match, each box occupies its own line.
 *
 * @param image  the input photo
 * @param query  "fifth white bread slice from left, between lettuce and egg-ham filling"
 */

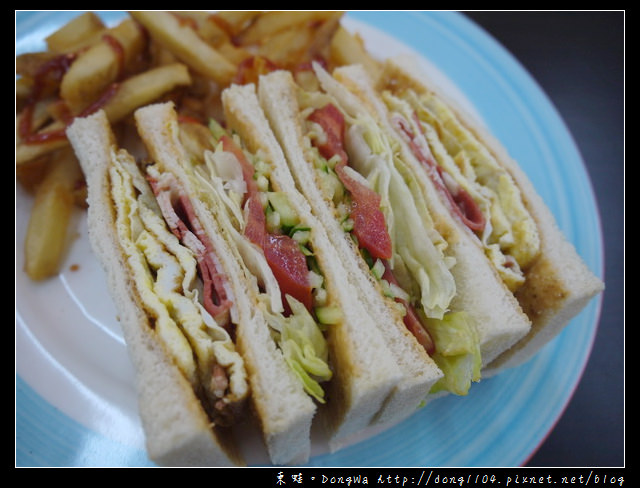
xmin=333 ymin=65 xmax=530 ymax=366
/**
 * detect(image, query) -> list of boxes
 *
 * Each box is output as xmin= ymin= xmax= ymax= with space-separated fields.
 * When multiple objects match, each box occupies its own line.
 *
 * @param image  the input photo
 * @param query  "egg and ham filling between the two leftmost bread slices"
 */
xmin=109 ymin=147 xmax=249 ymax=425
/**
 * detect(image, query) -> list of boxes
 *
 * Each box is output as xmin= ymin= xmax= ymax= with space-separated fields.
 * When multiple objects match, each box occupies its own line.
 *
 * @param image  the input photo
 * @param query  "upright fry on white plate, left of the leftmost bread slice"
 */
xmin=24 ymin=148 xmax=82 ymax=280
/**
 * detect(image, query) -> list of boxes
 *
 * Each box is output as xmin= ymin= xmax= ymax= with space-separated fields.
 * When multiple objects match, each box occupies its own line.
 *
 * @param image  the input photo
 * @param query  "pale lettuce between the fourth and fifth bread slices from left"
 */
xmin=305 ymin=68 xmax=482 ymax=395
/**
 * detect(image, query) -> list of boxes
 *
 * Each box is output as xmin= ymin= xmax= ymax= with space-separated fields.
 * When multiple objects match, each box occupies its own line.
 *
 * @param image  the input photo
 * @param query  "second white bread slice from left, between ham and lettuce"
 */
xmin=135 ymin=103 xmax=316 ymax=464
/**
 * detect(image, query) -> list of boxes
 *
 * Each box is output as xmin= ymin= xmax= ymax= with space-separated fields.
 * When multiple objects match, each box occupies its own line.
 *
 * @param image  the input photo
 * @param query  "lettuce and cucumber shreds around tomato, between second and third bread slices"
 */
xmin=179 ymin=120 xmax=339 ymax=403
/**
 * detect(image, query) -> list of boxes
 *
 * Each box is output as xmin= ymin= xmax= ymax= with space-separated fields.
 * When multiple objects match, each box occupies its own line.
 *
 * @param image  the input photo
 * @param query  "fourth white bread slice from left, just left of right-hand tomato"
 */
xmin=259 ymin=71 xmax=442 ymax=423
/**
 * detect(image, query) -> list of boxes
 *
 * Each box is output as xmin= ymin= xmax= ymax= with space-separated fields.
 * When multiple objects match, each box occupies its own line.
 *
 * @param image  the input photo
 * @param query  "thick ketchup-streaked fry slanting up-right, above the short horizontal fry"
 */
xmin=60 ymin=19 xmax=145 ymax=114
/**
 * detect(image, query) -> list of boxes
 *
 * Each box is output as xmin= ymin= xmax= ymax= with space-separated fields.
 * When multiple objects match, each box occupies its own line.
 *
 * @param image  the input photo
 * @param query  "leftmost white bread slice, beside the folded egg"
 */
xmin=67 ymin=111 xmax=243 ymax=466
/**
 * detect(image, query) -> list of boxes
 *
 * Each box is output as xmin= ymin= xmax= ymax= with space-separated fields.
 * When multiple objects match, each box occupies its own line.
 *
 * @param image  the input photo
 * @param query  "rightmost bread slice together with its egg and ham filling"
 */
xmin=334 ymin=57 xmax=604 ymax=376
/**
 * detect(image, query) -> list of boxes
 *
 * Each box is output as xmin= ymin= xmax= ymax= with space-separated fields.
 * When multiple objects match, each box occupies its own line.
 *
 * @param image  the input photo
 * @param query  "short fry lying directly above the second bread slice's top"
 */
xmin=103 ymin=63 xmax=191 ymax=124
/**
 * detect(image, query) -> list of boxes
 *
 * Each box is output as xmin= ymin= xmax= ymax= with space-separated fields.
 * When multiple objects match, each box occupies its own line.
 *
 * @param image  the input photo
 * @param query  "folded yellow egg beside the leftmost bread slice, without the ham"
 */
xmin=109 ymin=152 xmax=248 ymax=424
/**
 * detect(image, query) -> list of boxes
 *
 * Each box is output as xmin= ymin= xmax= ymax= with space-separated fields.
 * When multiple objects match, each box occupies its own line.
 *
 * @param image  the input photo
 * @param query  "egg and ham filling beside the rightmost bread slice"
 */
xmin=382 ymin=89 xmax=540 ymax=292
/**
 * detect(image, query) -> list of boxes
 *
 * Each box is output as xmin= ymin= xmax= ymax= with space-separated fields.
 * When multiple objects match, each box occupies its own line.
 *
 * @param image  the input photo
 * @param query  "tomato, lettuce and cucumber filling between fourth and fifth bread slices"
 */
xmin=298 ymin=67 xmax=481 ymax=394
